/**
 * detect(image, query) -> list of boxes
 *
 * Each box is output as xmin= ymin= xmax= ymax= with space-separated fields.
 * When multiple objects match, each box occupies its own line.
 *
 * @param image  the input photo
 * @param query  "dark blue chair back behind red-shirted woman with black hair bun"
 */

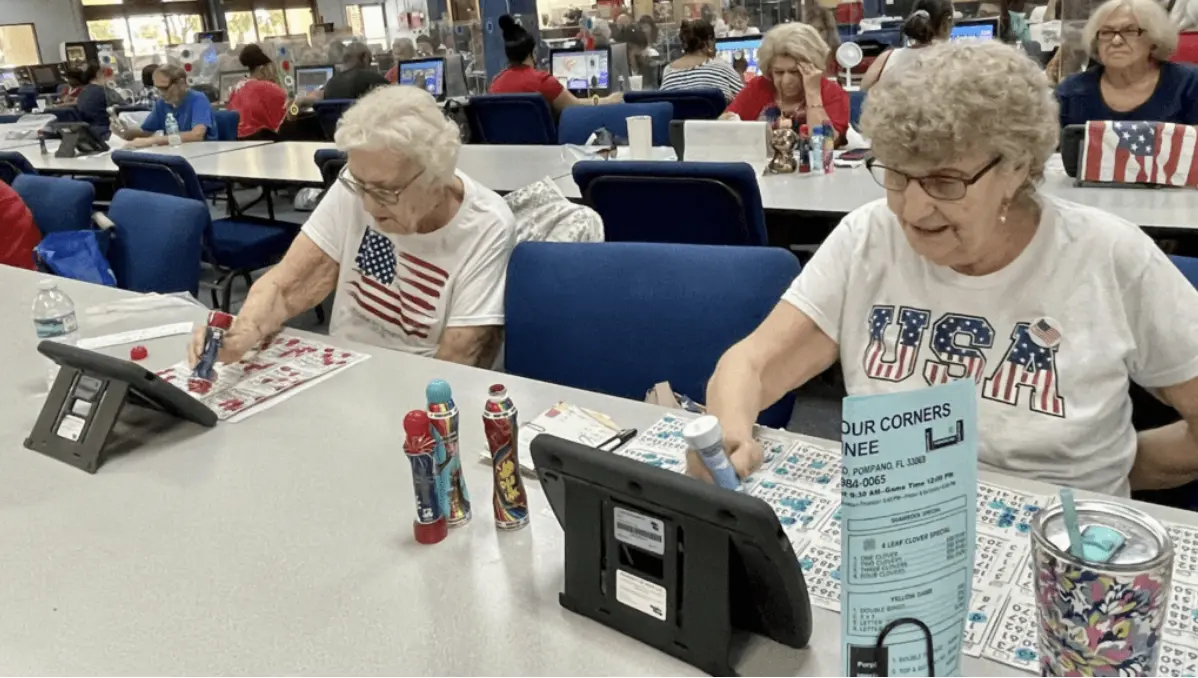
xmin=466 ymin=93 xmax=557 ymax=146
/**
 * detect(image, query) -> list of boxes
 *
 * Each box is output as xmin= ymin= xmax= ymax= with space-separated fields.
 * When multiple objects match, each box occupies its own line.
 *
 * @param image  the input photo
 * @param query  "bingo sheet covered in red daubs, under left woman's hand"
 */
xmin=158 ymin=334 xmax=370 ymax=422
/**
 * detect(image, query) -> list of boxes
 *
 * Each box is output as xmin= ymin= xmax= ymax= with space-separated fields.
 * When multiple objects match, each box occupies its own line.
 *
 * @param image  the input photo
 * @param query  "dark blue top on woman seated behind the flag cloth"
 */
xmin=1057 ymin=61 xmax=1198 ymax=127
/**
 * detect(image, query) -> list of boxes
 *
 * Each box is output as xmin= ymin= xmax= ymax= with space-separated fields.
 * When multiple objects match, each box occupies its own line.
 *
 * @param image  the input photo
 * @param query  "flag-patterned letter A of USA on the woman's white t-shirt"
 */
xmin=981 ymin=322 xmax=1065 ymax=418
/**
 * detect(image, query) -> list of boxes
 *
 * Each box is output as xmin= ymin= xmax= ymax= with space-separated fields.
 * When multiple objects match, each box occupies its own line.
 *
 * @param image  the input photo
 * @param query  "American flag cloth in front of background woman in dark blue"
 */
xmin=1081 ymin=120 xmax=1198 ymax=188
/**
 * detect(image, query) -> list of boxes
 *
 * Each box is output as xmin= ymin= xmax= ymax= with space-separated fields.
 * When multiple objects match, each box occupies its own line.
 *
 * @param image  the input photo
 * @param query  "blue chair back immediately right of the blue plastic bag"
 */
xmin=108 ymin=188 xmax=211 ymax=296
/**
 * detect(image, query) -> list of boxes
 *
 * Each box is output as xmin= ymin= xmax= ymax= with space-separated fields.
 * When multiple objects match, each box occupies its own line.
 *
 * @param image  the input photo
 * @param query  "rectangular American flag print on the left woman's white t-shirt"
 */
xmin=349 ymin=228 xmax=449 ymax=339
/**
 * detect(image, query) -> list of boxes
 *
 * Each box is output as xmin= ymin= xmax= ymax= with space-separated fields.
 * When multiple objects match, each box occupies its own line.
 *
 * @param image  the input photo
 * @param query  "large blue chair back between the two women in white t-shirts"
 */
xmin=504 ymin=242 xmax=799 ymax=426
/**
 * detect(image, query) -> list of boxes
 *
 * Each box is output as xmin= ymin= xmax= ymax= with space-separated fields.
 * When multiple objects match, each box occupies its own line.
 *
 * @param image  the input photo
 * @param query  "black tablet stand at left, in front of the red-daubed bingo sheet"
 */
xmin=25 ymin=341 xmax=217 ymax=473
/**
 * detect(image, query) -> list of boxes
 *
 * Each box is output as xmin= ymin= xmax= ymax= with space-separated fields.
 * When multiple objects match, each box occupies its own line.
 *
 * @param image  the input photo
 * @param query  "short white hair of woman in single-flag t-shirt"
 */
xmin=334 ymin=85 xmax=461 ymax=183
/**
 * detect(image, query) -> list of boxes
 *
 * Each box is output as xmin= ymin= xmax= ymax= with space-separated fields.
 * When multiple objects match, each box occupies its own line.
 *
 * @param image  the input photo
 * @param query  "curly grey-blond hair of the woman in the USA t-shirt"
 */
xmin=861 ymin=41 xmax=1060 ymax=192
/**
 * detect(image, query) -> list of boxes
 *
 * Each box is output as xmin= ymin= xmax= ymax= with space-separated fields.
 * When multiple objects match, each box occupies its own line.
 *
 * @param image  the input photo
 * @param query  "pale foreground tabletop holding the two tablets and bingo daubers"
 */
xmin=0 ymin=267 xmax=1198 ymax=676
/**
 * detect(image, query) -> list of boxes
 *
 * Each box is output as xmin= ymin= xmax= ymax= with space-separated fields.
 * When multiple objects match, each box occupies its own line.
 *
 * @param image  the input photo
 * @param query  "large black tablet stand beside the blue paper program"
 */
xmin=532 ymin=434 xmax=811 ymax=676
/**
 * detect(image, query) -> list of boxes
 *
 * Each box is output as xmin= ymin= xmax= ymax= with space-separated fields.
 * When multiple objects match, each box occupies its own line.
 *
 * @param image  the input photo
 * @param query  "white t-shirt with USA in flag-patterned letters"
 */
xmin=782 ymin=196 xmax=1198 ymax=496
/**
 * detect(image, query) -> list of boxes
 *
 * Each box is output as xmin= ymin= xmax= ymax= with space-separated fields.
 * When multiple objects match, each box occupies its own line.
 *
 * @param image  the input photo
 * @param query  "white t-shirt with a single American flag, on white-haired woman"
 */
xmin=303 ymin=171 xmax=516 ymax=356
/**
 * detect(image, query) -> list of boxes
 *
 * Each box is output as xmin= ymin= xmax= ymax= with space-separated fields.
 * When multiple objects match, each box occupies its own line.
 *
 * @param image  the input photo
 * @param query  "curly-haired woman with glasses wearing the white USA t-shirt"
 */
xmin=688 ymin=42 xmax=1198 ymax=496
